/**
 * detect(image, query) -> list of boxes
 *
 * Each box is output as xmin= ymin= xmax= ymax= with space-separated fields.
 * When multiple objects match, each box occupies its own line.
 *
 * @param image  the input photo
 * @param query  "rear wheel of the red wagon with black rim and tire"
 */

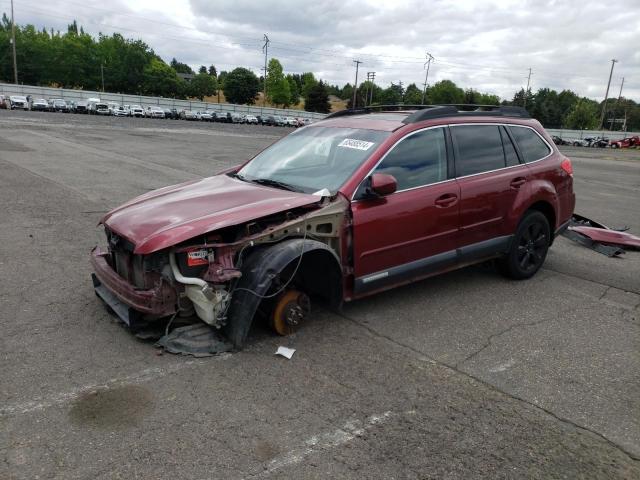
xmin=498 ymin=210 xmax=551 ymax=280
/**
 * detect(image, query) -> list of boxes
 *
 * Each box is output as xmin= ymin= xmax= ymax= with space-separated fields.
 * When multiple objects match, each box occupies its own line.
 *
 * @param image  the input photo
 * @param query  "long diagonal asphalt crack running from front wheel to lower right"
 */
xmin=337 ymin=312 xmax=640 ymax=462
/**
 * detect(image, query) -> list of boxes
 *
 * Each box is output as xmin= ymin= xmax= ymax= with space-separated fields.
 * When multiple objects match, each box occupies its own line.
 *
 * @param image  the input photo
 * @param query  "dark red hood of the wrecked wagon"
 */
xmin=100 ymin=175 xmax=320 ymax=254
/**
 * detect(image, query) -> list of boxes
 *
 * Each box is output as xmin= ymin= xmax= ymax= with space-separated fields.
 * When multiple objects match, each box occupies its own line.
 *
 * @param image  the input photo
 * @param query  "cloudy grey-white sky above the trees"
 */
xmin=6 ymin=0 xmax=640 ymax=101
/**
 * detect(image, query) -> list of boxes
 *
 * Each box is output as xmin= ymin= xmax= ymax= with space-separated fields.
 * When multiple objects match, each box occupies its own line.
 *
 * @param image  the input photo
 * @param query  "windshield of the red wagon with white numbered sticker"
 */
xmin=238 ymin=127 xmax=391 ymax=194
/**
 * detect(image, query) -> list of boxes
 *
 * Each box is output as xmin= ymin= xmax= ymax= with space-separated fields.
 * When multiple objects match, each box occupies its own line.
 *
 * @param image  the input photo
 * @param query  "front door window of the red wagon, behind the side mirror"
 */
xmin=375 ymin=128 xmax=447 ymax=191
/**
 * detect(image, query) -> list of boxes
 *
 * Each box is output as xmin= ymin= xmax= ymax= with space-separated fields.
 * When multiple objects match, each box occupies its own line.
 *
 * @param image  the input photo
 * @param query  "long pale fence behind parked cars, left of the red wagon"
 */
xmin=0 ymin=83 xmax=325 ymax=120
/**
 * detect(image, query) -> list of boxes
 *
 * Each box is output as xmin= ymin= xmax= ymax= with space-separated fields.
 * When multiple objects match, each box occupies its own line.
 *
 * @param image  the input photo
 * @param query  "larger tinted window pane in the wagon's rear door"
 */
xmin=451 ymin=125 xmax=505 ymax=177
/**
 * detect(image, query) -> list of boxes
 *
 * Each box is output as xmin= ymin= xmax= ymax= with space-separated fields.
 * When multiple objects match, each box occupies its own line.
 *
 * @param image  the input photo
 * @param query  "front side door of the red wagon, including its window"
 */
xmin=352 ymin=127 xmax=460 ymax=295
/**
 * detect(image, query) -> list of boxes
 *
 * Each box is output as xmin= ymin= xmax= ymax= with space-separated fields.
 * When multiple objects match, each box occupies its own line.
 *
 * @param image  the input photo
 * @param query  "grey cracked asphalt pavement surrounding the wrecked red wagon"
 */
xmin=0 ymin=110 xmax=640 ymax=479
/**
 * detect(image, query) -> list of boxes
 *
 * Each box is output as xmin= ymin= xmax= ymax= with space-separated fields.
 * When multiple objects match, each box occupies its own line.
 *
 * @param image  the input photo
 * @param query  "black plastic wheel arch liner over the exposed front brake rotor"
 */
xmin=224 ymin=238 xmax=343 ymax=348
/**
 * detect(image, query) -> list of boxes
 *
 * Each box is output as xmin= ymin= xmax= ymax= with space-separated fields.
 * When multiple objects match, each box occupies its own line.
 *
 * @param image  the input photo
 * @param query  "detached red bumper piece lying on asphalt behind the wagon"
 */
xmin=562 ymin=214 xmax=640 ymax=257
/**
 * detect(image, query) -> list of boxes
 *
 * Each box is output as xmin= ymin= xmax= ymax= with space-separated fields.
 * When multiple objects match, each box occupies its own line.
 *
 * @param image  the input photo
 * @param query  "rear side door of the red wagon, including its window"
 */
xmin=450 ymin=124 xmax=529 ymax=263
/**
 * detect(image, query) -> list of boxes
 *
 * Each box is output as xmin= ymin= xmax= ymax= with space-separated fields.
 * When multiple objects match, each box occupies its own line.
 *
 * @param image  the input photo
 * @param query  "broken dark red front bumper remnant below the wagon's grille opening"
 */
xmin=91 ymin=247 xmax=176 ymax=323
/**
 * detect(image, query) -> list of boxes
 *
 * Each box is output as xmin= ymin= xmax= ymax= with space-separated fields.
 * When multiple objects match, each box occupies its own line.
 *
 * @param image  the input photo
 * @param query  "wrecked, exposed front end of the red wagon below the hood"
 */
xmin=91 ymin=194 xmax=349 ymax=355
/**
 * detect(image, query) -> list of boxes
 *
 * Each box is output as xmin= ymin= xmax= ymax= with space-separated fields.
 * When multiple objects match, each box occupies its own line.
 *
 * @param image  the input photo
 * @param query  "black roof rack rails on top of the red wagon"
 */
xmin=325 ymin=104 xmax=531 ymax=123
